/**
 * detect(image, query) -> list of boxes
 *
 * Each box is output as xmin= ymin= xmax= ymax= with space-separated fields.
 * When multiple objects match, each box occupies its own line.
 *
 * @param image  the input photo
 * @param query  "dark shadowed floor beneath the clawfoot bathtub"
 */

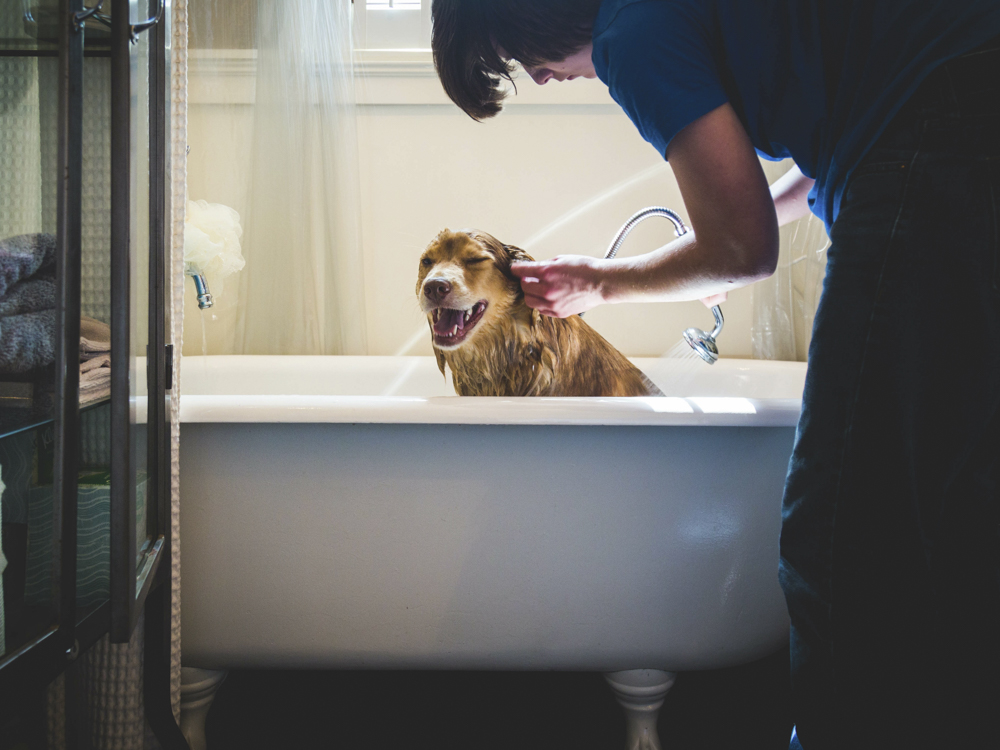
xmin=207 ymin=652 xmax=792 ymax=750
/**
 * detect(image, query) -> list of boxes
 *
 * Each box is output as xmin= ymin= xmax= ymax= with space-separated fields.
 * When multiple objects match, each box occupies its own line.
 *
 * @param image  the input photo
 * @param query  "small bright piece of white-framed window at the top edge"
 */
xmin=354 ymin=0 xmax=431 ymax=50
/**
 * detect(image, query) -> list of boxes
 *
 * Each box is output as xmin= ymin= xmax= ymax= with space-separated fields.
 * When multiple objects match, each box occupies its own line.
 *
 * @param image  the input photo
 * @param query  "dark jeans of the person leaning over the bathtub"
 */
xmin=780 ymin=40 xmax=1000 ymax=750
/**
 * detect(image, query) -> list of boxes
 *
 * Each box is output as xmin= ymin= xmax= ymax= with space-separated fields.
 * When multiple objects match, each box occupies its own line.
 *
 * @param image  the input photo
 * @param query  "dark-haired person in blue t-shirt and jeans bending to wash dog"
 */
xmin=432 ymin=0 xmax=1000 ymax=750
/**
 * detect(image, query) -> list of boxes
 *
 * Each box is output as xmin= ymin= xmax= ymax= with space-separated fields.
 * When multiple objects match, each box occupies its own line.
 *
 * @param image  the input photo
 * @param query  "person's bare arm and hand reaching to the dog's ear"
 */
xmin=512 ymin=104 xmax=780 ymax=317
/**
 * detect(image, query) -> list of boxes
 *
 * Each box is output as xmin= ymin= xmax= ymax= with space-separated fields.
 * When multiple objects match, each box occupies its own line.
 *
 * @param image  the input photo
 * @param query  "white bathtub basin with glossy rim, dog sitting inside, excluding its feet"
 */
xmin=181 ymin=356 xmax=805 ymax=672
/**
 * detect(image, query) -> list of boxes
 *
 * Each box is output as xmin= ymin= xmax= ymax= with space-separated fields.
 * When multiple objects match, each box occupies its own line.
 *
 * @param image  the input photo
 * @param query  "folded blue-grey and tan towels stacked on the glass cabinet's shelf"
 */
xmin=0 ymin=234 xmax=111 ymax=404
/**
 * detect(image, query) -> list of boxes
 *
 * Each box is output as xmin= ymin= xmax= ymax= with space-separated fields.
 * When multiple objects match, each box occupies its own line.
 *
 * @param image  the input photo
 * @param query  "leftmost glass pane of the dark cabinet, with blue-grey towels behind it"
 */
xmin=0 ymin=0 xmax=59 ymax=653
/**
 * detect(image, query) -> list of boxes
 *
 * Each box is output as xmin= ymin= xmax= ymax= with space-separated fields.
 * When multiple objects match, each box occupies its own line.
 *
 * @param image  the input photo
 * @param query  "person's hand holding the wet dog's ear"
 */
xmin=510 ymin=255 xmax=606 ymax=318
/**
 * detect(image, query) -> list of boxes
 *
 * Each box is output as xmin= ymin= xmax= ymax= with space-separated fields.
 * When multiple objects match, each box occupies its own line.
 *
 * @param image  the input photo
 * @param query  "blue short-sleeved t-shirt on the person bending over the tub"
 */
xmin=593 ymin=0 xmax=1000 ymax=229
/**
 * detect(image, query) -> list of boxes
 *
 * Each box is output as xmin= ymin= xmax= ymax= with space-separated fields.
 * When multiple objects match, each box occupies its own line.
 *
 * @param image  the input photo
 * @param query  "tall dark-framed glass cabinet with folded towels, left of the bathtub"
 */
xmin=0 ymin=0 xmax=185 ymax=748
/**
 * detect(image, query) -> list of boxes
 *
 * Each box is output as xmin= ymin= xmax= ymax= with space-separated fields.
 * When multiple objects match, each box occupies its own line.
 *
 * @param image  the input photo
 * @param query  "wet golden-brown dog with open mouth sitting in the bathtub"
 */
xmin=416 ymin=229 xmax=663 ymax=396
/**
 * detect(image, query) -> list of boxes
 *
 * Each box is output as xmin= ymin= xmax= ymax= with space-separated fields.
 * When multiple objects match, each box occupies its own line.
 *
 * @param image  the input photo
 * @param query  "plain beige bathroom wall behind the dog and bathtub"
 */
xmin=184 ymin=50 xmax=782 ymax=357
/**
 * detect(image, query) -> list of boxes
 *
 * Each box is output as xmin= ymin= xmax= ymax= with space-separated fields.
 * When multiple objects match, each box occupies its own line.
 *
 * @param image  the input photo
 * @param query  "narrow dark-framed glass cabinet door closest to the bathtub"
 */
xmin=111 ymin=0 xmax=166 ymax=641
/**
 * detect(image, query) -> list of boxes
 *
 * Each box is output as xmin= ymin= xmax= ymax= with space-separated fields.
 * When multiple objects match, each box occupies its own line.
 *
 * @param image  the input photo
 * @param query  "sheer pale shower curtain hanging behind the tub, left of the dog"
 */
xmin=188 ymin=0 xmax=366 ymax=354
